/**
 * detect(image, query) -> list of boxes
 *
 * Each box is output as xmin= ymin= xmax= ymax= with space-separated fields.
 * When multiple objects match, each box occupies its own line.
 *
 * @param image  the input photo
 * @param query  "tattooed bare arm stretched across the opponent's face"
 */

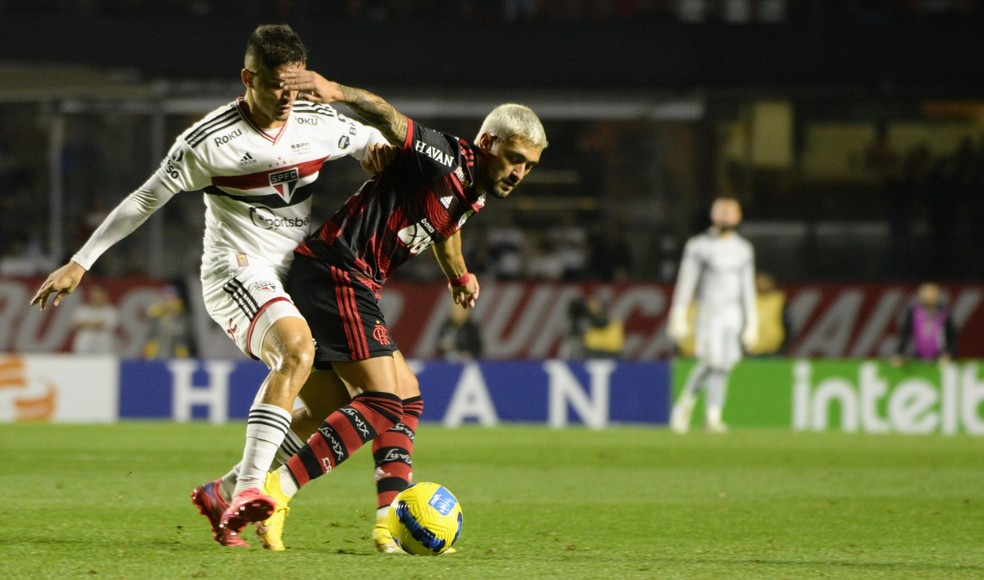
xmin=280 ymin=70 xmax=408 ymax=147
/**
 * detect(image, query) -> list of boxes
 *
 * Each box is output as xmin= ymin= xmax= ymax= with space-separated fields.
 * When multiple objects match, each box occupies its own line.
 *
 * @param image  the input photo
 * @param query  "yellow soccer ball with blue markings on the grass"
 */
xmin=388 ymin=481 xmax=461 ymax=556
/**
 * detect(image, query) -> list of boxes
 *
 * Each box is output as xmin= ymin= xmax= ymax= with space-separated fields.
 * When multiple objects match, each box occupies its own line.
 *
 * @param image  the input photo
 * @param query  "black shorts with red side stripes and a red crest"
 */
xmin=287 ymin=254 xmax=398 ymax=370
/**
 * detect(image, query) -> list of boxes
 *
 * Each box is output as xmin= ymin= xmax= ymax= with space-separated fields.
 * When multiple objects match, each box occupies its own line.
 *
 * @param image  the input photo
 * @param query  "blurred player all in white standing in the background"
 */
xmin=667 ymin=197 xmax=758 ymax=433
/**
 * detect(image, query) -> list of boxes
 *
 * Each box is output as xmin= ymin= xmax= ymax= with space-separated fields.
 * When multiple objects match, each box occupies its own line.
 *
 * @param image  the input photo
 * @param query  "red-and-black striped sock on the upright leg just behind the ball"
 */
xmin=372 ymin=397 xmax=424 ymax=507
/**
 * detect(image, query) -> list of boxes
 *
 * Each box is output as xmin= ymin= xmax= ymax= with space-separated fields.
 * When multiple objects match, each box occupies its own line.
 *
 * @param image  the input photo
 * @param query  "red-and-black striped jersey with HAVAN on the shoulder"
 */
xmin=296 ymin=119 xmax=485 ymax=289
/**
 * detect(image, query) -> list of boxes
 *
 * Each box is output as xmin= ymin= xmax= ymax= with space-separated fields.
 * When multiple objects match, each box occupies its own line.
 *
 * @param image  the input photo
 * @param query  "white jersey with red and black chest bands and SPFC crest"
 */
xmin=158 ymin=98 xmax=385 ymax=277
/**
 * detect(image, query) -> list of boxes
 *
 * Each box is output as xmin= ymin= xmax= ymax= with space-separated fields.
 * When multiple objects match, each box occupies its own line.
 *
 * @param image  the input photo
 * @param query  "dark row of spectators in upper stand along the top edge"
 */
xmin=0 ymin=0 xmax=984 ymax=24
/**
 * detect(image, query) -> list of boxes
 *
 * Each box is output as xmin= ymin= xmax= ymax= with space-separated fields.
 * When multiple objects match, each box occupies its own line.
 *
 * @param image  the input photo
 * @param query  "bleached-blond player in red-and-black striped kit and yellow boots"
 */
xmin=243 ymin=71 xmax=547 ymax=550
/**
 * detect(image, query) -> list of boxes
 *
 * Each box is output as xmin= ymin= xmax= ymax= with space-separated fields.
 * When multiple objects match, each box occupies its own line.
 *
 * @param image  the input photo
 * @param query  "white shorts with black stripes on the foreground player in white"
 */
xmin=202 ymin=257 xmax=304 ymax=359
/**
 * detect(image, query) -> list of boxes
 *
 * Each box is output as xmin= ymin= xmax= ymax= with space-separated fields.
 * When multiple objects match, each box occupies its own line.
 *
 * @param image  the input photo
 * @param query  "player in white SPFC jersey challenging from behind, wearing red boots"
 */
xmin=31 ymin=25 xmax=387 ymax=545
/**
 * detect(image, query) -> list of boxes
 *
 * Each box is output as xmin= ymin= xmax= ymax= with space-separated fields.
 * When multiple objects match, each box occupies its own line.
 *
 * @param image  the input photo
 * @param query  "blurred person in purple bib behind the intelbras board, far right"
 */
xmin=891 ymin=282 xmax=957 ymax=366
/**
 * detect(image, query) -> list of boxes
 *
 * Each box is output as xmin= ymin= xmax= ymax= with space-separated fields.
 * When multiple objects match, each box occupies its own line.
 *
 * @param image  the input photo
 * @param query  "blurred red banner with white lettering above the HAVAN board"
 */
xmin=0 ymin=278 xmax=984 ymax=360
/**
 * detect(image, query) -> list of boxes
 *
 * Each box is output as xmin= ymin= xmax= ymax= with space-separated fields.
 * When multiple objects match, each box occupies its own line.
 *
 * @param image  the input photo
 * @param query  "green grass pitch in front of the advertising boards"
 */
xmin=0 ymin=422 xmax=984 ymax=578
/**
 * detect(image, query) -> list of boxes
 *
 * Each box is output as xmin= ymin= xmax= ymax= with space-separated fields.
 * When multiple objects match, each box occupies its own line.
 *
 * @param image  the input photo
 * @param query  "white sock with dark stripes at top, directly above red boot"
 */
xmin=236 ymin=403 xmax=290 ymax=494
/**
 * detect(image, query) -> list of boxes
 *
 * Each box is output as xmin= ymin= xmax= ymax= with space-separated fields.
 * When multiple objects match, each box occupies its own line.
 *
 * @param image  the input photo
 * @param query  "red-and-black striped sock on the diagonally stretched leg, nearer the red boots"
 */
xmin=287 ymin=393 xmax=403 ymax=487
